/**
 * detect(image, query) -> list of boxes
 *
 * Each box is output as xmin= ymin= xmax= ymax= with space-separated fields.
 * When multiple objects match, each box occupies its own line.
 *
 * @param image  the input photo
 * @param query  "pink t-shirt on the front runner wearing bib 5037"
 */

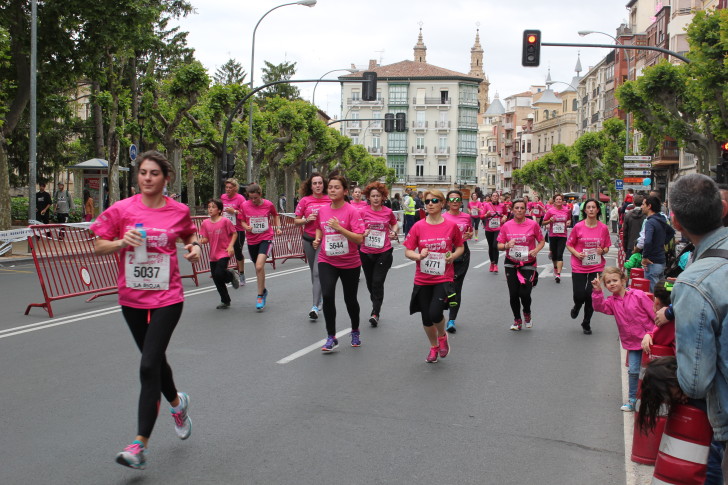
xmin=91 ymin=194 xmax=197 ymax=309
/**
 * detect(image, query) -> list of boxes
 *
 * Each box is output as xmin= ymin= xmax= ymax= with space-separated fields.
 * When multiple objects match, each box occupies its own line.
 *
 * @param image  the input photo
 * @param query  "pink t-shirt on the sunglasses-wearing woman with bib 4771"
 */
xmin=404 ymin=219 xmax=463 ymax=285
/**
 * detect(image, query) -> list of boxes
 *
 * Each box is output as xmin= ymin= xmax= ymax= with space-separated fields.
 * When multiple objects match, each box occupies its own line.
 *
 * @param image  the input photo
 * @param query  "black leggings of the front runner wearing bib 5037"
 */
xmin=121 ymin=302 xmax=182 ymax=438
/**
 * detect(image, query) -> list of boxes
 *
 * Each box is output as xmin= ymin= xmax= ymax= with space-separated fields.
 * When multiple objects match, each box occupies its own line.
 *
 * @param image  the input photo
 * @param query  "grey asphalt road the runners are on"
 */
xmin=0 ymin=233 xmax=626 ymax=485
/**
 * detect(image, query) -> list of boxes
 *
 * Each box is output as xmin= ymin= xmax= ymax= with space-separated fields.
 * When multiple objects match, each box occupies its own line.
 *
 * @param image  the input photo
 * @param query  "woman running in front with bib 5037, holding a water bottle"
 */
xmin=91 ymin=151 xmax=200 ymax=469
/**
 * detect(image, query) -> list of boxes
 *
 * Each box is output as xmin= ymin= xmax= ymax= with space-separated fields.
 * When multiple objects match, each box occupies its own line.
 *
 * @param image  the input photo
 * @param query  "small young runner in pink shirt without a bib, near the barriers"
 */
xmin=200 ymin=199 xmax=240 ymax=310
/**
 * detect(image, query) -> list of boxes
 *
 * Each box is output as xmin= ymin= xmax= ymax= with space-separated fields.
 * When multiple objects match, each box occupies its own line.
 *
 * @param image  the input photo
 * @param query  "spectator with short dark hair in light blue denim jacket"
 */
xmin=670 ymin=174 xmax=728 ymax=476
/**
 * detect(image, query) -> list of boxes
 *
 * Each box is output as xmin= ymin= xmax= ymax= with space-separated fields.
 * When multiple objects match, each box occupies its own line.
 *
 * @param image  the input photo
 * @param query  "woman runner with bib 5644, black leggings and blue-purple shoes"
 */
xmin=313 ymin=175 xmax=364 ymax=352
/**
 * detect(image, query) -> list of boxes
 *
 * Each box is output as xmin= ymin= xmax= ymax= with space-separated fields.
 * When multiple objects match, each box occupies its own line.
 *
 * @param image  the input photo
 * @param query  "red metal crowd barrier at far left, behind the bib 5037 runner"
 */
xmin=25 ymin=224 xmax=119 ymax=317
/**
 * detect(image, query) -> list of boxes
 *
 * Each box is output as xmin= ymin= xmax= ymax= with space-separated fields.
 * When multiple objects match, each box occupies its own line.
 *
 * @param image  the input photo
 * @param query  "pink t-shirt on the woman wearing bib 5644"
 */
xmin=316 ymin=203 xmax=364 ymax=269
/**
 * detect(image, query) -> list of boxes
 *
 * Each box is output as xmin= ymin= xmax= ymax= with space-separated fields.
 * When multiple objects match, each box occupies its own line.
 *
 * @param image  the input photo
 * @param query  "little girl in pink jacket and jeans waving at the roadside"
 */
xmin=592 ymin=266 xmax=655 ymax=412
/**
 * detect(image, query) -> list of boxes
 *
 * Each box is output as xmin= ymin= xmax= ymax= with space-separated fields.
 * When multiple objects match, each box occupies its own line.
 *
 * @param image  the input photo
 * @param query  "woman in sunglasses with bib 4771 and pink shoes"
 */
xmin=404 ymin=190 xmax=465 ymax=364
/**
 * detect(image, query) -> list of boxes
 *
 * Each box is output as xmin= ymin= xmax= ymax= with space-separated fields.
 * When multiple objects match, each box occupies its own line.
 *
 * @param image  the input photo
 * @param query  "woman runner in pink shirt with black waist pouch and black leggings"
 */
xmin=498 ymin=199 xmax=546 ymax=331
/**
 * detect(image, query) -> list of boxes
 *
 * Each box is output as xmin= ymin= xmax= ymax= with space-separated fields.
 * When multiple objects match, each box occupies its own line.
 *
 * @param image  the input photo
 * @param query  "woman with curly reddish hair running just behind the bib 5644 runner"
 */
xmin=359 ymin=182 xmax=397 ymax=327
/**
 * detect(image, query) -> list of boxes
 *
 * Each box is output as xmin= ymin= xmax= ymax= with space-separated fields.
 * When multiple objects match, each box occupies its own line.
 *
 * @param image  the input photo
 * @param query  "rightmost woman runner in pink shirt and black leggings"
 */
xmin=566 ymin=199 xmax=612 ymax=335
